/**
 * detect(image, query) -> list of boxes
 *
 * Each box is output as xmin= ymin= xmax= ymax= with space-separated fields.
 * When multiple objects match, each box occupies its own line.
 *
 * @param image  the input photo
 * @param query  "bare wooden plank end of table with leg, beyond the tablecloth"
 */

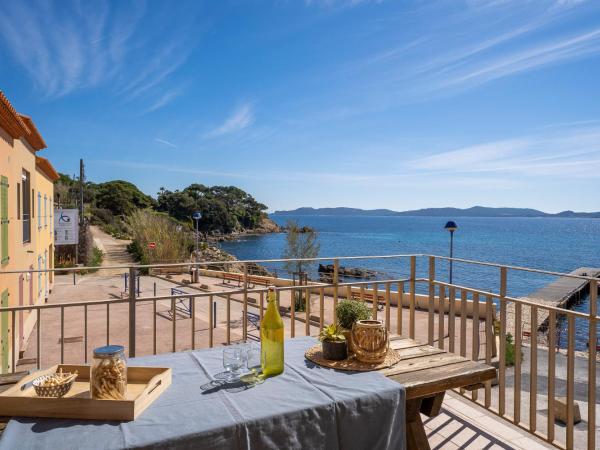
xmin=381 ymin=335 xmax=496 ymax=450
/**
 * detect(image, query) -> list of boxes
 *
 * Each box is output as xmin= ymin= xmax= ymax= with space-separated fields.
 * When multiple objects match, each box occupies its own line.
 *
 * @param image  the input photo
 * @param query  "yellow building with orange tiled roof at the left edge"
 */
xmin=0 ymin=91 xmax=58 ymax=373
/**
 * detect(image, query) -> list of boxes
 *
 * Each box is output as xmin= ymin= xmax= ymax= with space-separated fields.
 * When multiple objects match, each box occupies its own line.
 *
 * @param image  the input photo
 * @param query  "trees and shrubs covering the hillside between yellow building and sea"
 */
xmin=55 ymin=174 xmax=280 ymax=262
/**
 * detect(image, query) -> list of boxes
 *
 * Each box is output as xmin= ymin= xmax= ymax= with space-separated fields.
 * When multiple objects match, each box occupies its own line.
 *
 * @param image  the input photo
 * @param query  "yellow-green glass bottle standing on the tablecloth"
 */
xmin=260 ymin=286 xmax=283 ymax=377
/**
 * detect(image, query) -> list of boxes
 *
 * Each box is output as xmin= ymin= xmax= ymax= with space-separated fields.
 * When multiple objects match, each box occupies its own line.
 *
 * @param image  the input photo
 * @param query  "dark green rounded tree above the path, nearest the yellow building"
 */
xmin=92 ymin=180 xmax=154 ymax=216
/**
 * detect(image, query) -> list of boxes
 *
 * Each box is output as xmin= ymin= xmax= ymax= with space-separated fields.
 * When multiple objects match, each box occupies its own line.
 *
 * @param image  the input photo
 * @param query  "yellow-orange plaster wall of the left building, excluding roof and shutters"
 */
xmin=0 ymin=123 xmax=54 ymax=371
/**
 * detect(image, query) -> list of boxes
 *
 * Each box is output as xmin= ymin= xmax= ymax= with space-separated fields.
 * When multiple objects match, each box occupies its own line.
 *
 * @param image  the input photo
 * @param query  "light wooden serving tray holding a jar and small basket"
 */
xmin=0 ymin=364 xmax=171 ymax=420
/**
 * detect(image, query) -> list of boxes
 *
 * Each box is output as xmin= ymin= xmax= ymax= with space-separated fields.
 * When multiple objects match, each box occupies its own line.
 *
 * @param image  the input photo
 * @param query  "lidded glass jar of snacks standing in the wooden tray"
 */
xmin=90 ymin=345 xmax=127 ymax=400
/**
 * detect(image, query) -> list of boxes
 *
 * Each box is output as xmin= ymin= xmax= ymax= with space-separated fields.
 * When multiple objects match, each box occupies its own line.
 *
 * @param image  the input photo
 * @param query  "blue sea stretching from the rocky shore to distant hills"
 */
xmin=221 ymin=214 xmax=600 ymax=349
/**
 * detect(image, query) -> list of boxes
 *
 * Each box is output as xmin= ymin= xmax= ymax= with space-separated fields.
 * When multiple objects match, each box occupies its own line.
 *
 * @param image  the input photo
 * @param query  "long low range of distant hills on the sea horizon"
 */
xmin=275 ymin=206 xmax=600 ymax=218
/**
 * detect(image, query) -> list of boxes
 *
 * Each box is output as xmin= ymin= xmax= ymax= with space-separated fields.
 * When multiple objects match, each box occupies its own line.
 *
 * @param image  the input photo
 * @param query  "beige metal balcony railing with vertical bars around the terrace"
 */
xmin=0 ymin=255 xmax=600 ymax=449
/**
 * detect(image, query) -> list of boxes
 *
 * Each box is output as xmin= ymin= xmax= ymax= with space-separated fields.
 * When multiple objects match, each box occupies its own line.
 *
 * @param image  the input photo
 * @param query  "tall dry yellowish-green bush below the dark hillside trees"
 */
xmin=125 ymin=209 xmax=193 ymax=264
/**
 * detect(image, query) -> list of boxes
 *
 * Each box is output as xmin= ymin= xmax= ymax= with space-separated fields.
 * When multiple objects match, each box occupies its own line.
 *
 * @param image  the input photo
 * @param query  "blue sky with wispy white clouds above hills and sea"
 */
xmin=0 ymin=0 xmax=600 ymax=212
